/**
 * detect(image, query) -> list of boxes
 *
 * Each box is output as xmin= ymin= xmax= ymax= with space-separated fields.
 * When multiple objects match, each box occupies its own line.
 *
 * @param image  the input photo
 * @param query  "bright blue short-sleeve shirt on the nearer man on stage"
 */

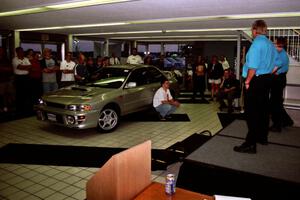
xmin=242 ymin=35 xmax=281 ymax=78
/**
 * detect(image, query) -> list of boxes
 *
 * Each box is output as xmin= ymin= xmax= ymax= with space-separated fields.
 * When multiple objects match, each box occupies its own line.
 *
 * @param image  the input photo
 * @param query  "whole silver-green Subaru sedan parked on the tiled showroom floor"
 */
xmin=36 ymin=65 xmax=178 ymax=132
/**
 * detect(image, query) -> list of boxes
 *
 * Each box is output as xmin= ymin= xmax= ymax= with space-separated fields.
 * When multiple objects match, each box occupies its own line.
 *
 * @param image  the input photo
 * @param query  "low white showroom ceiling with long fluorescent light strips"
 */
xmin=0 ymin=0 xmax=300 ymax=41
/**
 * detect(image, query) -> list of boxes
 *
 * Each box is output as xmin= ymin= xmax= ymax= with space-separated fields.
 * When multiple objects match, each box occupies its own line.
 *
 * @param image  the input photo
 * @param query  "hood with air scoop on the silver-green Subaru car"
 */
xmin=43 ymin=86 xmax=116 ymax=104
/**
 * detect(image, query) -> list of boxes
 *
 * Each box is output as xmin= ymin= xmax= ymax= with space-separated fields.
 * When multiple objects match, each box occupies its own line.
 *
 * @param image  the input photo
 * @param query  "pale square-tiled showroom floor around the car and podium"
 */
xmin=0 ymin=102 xmax=222 ymax=200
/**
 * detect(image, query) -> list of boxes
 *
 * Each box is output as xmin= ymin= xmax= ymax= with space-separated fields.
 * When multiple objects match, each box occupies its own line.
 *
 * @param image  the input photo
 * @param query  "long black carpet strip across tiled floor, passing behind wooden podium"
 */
xmin=0 ymin=133 xmax=210 ymax=171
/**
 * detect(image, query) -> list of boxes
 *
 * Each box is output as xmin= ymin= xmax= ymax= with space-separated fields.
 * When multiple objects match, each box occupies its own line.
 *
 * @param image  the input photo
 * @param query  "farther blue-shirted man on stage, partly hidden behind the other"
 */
xmin=270 ymin=37 xmax=294 ymax=132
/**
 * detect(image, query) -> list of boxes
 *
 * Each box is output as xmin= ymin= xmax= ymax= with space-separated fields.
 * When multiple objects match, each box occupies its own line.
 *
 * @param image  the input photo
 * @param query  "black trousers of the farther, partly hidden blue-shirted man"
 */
xmin=270 ymin=73 xmax=292 ymax=128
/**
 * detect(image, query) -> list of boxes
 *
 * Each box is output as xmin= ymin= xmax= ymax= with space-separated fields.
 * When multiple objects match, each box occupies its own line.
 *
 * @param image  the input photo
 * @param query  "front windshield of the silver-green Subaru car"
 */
xmin=86 ymin=67 xmax=130 ymax=88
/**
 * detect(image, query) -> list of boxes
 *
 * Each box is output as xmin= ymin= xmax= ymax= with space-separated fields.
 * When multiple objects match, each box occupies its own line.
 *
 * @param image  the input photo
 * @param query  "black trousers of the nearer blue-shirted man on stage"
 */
xmin=245 ymin=74 xmax=271 ymax=144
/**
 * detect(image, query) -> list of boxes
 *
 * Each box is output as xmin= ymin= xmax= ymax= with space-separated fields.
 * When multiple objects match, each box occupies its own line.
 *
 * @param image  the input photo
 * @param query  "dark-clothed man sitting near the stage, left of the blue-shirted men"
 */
xmin=217 ymin=69 xmax=239 ymax=113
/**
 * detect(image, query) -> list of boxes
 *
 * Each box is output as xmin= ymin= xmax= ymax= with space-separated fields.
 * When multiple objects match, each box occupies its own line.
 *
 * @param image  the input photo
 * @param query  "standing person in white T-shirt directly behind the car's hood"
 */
xmin=60 ymin=52 xmax=76 ymax=87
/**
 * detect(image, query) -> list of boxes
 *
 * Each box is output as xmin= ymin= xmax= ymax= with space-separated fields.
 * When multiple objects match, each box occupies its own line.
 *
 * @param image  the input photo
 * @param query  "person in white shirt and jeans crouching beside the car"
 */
xmin=153 ymin=79 xmax=180 ymax=120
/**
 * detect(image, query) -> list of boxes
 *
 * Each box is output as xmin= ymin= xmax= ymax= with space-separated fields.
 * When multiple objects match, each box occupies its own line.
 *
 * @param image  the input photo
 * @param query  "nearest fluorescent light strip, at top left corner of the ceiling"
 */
xmin=0 ymin=0 xmax=137 ymax=17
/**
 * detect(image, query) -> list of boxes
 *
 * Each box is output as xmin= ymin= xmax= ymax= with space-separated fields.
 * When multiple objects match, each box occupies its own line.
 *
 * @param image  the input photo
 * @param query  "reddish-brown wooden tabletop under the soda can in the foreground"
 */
xmin=135 ymin=182 xmax=214 ymax=200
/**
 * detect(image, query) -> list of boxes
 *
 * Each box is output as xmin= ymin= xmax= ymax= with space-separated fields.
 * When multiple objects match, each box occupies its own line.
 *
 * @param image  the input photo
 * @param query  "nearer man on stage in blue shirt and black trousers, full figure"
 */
xmin=233 ymin=20 xmax=280 ymax=154
